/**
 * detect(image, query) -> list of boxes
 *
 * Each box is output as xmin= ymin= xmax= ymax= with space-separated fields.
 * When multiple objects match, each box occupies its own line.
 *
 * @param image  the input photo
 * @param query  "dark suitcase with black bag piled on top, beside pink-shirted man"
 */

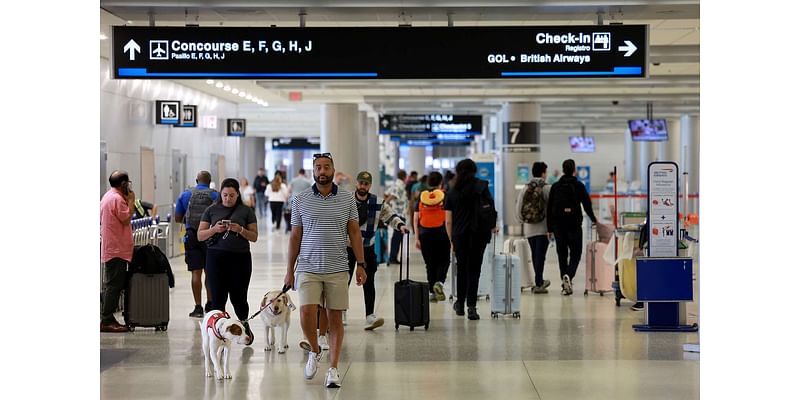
xmin=122 ymin=244 xmax=175 ymax=331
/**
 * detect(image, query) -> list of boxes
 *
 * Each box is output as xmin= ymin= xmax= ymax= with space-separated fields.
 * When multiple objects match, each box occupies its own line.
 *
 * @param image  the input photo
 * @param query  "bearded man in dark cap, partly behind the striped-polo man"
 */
xmin=347 ymin=171 xmax=408 ymax=331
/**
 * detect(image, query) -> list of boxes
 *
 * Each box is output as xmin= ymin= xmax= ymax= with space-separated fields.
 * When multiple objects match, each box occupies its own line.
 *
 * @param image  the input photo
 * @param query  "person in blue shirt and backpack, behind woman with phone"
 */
xmin=175 ymin=171 xmax=219 ymax=318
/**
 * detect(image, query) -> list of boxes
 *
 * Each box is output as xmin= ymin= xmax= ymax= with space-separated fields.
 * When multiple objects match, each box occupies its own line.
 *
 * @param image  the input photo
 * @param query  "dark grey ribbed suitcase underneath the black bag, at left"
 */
xmin=122 ymin=273 xmax=169 ymax=331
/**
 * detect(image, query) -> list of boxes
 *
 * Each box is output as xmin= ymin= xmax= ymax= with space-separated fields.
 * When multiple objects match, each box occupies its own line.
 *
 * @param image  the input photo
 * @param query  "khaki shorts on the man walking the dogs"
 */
xmin=296 ymin=271 xmax=350 ymax=310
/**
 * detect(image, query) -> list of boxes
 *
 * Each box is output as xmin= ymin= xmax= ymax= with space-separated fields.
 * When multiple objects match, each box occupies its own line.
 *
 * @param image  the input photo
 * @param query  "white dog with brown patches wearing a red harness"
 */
xmin=200 ymin=310 xmax=247 ymax=380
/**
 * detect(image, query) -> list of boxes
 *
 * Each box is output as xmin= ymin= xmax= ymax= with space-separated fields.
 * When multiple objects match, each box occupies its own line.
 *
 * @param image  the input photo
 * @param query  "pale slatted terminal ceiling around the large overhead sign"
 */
xmin=100 ymin=0 xmax=700 ymax=136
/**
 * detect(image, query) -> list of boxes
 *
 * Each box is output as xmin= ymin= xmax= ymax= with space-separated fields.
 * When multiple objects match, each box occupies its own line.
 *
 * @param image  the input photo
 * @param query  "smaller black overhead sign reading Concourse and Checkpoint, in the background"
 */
xmin=378 ymin=114 xmax=483 ymax=135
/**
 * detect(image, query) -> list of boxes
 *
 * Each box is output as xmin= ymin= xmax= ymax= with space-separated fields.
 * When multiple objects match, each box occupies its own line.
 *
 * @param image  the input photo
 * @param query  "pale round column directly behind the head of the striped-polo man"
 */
xmin=320 ymin=104 xmax=359 ymax=184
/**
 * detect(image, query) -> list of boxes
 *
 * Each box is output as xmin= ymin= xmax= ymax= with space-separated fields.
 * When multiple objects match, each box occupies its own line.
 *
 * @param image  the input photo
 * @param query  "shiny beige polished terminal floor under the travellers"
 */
xmin=100 ymin=222 xmax=700 ymax=400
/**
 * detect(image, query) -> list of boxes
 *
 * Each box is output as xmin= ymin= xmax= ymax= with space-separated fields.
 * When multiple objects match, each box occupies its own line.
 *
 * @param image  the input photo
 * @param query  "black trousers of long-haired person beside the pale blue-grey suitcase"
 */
xmin=453 ymin=233 xmax=492 ymax=307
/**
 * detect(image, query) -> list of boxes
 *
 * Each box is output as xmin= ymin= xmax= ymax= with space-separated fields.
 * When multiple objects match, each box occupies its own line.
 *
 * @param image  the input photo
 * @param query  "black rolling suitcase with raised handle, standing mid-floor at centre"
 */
xmin=394 ymin=234 xmax=431 ymax=331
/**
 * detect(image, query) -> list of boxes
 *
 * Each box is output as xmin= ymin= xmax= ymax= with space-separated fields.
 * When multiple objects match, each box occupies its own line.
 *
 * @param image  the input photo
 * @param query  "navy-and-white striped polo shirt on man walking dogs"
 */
xmin=292 ymin=183 xmax=358 ymax=274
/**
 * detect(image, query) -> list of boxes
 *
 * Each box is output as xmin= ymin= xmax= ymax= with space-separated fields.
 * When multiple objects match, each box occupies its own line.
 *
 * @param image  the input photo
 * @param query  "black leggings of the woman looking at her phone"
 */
xmin=206 ymin=249 xmax=253 ymax=321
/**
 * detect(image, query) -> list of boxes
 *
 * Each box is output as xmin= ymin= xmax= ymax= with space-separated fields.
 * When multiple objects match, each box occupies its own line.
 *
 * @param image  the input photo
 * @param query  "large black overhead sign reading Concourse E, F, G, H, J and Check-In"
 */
xmin=112 ymin=25 xmax=648 ymax=79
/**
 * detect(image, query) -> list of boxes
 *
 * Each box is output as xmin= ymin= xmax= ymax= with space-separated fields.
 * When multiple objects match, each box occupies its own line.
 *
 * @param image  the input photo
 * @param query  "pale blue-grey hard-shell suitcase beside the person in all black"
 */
xmin=491 ymin=235 xmax=522 ymax=318
